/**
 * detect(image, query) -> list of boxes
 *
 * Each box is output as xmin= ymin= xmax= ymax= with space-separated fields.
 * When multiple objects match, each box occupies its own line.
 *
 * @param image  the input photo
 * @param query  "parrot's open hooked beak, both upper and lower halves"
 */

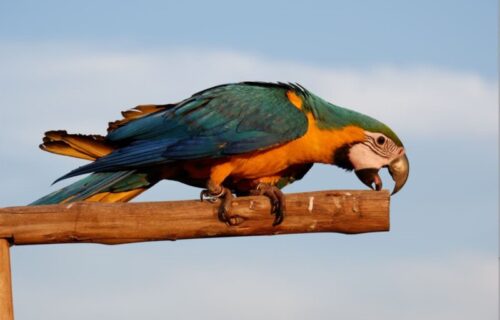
xmin=356 ymin=155 xmax=410 ymax=195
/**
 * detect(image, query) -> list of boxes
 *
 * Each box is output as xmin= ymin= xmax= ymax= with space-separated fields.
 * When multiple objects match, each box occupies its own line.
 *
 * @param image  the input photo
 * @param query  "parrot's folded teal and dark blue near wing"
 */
xmin=58 ymin=82 xmax=308 ymax=180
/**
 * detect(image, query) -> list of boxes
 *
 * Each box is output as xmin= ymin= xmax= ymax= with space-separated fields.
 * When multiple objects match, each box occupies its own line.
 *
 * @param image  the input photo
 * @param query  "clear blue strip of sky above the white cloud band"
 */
xmin=0 ymin=0 xmax=497 ymax=77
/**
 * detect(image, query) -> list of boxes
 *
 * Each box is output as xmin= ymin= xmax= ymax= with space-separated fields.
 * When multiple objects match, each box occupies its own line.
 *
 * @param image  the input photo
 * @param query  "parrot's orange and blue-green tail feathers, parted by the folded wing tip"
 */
xmin=30 ymin=131 xmax=157 ymax=205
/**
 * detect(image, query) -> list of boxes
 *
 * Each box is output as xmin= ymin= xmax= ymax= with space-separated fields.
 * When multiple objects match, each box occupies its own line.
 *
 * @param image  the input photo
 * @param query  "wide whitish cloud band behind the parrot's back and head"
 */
xmin=0 ymin=45 xmax=498 ymax=145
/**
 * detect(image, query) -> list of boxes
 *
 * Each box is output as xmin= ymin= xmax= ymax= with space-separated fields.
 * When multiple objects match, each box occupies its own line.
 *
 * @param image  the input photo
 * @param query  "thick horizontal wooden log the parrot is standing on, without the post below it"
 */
xmin=0 ymin=190 xmax=390 ymax=245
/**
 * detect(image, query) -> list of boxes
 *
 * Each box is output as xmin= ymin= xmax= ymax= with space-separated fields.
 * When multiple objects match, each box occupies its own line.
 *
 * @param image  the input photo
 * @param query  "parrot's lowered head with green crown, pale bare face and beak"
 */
xmin=298 ymin=86 xmax=410 ymax=194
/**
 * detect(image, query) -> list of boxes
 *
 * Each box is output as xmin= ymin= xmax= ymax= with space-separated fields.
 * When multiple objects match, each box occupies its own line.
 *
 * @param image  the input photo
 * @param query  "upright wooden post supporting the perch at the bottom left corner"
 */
xmin=0 ymin=239 xmax=14 ymax=320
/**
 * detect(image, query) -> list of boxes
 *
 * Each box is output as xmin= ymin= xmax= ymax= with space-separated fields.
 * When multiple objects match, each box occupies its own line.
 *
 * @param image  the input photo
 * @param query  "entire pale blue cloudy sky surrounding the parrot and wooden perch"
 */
xmin=0 ymin=1 xmax=498 ymax=320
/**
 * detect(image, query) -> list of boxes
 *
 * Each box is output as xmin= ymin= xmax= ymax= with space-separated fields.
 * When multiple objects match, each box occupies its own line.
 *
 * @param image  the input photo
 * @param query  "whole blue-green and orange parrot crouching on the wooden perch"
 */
xmin=30 ymin=81 xmax=409 ymax=226
